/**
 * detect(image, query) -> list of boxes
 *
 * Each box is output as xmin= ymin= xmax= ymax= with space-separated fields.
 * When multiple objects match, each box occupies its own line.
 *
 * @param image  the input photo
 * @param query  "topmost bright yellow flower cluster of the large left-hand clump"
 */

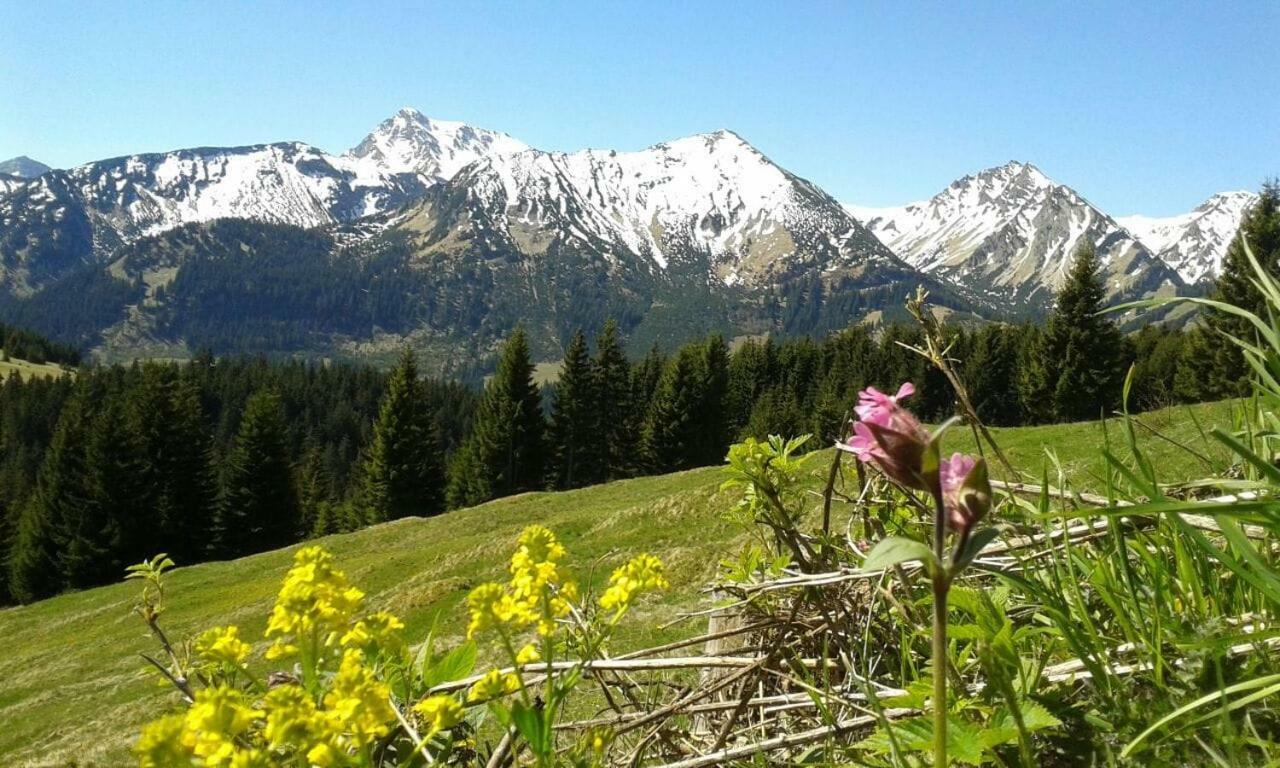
xmin=266 ymin=547 xmax=365 ymax=659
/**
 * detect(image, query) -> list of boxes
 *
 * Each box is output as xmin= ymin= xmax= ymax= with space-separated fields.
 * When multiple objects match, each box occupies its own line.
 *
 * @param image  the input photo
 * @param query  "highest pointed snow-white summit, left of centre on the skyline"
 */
xmin=344 ymin=108 xmax=529 ymax=184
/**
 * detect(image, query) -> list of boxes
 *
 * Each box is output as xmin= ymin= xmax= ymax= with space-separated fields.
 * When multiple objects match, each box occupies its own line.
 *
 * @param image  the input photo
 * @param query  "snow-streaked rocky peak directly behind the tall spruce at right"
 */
xmin=847 ymin=163 xmax=1183 ymax=307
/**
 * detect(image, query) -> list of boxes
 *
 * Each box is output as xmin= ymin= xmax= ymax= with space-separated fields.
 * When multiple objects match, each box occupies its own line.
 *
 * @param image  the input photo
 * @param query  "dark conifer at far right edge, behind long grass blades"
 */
xmin=1203 ymin=180 xmax=1280 ymax=397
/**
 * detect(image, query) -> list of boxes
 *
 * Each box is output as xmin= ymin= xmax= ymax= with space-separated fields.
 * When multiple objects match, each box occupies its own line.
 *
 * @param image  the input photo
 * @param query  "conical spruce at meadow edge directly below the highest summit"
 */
xmin=364 ymin=349 xmax=444 ymax=522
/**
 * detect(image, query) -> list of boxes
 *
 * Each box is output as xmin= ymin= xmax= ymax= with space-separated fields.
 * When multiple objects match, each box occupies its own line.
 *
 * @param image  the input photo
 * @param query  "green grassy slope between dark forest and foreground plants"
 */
xmin=0 ymin=404 xmax=1230 ymax=765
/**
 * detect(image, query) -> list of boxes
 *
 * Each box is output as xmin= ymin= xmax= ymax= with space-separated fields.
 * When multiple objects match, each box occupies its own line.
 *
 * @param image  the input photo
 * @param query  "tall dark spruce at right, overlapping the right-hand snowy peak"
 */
xmin=1024 ymin=244 xmax=1124 ymax=421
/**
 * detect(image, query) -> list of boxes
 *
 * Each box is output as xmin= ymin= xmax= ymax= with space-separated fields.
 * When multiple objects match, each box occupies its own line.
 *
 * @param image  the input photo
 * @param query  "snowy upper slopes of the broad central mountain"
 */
xmin=409 ymin=131 xmax=899 ymax=285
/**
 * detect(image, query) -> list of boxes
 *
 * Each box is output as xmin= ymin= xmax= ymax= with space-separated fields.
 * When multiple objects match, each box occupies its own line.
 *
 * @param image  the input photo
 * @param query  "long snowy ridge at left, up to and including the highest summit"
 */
xmin=0 ymin=110 xmax=524 ymax=292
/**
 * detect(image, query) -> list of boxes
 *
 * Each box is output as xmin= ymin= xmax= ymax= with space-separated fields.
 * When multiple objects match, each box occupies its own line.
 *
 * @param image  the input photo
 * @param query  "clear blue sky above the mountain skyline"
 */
xmin=0 ymin=0 xmax=1280 ymax=215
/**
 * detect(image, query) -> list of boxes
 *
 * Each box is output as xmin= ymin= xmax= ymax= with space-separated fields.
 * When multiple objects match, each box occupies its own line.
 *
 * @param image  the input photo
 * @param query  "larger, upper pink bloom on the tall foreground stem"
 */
xmin=837 ymin=381 xmax=933 ymax=490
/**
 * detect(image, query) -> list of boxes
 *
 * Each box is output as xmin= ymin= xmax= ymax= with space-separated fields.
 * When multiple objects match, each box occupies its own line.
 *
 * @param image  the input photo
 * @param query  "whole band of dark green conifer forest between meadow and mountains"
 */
xmin=0 ymin=185 xmax=1280 ymax=602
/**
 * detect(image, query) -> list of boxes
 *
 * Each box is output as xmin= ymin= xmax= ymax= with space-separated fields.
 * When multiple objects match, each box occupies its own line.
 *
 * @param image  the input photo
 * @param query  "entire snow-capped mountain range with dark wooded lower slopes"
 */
xmin=0 ymin=109 xmax=1252 ymax=365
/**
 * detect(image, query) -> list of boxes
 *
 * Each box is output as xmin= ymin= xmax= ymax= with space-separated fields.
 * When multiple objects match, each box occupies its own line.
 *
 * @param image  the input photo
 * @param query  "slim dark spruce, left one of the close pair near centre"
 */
xmin=548 ymin=330 xmax=596 ymax=489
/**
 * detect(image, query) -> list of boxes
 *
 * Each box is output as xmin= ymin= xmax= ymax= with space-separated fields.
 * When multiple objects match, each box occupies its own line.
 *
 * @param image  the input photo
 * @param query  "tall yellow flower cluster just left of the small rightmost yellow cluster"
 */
xmin=467 ymin=525 xmax=577 ymax=637
